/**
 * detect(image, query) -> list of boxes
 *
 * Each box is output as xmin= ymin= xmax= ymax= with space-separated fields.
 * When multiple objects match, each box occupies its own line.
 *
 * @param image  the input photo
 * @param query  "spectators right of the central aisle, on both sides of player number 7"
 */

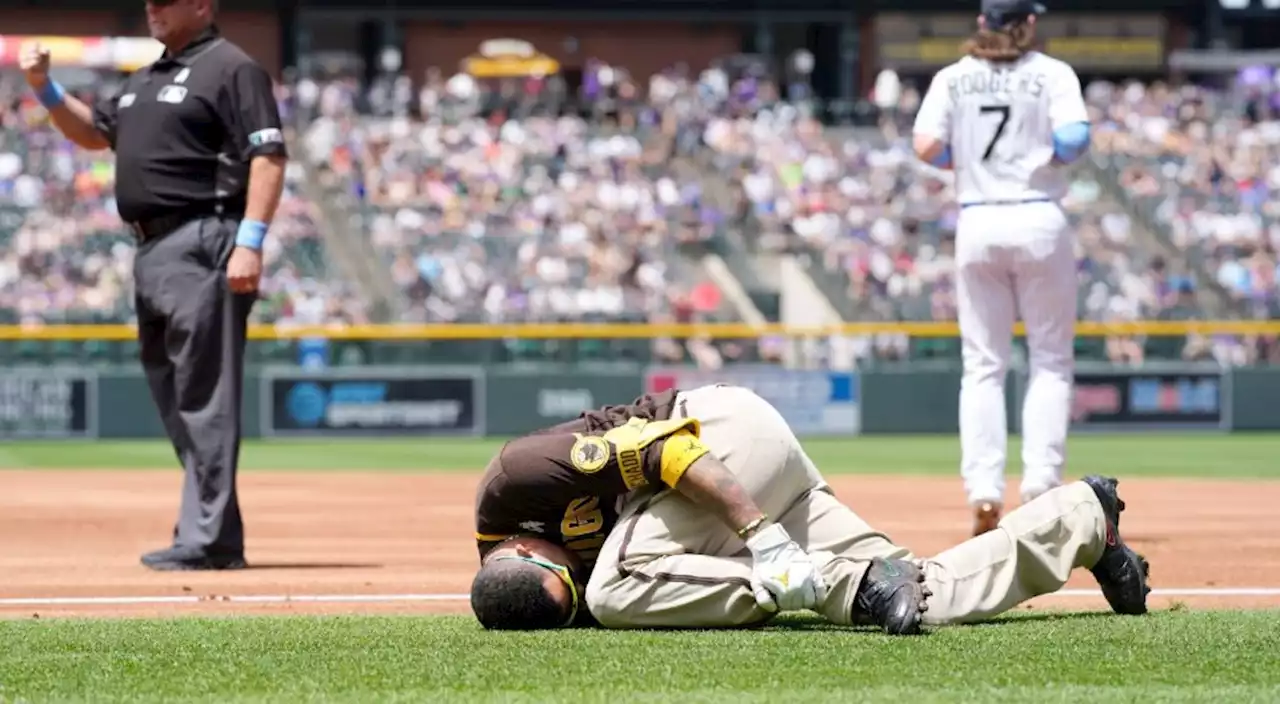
xmin=704 ymin=70 xmax=1280 ymax=364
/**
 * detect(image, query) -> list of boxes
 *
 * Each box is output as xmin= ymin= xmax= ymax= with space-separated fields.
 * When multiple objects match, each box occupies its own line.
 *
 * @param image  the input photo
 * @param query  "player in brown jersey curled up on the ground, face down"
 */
xmin=471 ymin=385 xmax=1149 ymax=635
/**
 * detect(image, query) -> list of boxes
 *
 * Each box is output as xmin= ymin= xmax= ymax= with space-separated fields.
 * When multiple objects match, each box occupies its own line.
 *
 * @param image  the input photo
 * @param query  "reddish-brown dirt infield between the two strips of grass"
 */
xmin=0 ymin=471 xmax=1280 ymax=618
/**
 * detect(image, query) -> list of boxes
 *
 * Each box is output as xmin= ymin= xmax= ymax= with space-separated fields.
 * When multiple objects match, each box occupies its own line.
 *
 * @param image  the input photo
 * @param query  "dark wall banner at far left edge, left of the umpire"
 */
xmin=0 ymin=367 xmax=97 ymax=439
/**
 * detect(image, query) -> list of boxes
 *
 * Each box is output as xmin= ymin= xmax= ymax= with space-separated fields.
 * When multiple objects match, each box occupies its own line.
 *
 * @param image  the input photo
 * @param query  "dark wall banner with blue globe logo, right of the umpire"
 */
xmin=260 ymin=366 xmax=485 ymax=436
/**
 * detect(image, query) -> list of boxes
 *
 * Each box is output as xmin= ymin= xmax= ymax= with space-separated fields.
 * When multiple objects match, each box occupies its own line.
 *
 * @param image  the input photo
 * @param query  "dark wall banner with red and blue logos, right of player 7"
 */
xmin=1071 ymin=367 xmax=1231 ymax=430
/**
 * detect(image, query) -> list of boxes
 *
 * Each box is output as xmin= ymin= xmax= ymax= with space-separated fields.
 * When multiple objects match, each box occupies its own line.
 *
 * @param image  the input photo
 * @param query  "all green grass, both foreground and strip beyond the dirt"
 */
xmin=0 ymin=435 xmax=1280 ymax=704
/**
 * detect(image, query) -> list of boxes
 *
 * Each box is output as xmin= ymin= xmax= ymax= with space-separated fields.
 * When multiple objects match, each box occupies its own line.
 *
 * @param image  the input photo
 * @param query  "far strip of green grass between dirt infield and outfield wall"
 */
xmin=0 ymin=434 xmax=1280 ymax=479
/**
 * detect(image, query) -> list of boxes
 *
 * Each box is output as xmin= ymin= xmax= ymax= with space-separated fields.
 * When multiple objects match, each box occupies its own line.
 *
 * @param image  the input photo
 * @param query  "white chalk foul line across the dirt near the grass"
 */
xmin=0 ymin=586 xmax=1280 ymax=607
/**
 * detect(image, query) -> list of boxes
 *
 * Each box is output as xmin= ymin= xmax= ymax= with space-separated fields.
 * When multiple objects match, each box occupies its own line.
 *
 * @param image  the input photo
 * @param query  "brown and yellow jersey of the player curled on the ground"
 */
xmin=476 ymin=390 xmax=708 ymax=572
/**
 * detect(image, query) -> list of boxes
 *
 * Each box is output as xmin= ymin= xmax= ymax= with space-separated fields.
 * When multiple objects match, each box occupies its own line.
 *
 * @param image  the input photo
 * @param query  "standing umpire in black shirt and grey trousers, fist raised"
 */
xmin=20 ymin=0 xmax=287 ymax=570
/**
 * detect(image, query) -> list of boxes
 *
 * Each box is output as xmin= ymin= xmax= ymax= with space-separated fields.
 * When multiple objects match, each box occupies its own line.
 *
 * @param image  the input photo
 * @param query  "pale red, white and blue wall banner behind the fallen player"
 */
xmin=645 ymin=365 xmax=861 ymax=435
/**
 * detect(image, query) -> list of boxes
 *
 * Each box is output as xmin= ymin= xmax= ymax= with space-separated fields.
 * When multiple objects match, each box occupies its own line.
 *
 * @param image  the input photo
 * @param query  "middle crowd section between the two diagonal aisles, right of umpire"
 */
xmin=293 ymin=67 xmax=714 ymax=321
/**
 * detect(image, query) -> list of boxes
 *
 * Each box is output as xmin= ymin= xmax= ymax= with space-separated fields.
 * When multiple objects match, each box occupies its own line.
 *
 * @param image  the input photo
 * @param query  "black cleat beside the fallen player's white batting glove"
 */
xmin=854 ymin=558 xmax=932 ymax=636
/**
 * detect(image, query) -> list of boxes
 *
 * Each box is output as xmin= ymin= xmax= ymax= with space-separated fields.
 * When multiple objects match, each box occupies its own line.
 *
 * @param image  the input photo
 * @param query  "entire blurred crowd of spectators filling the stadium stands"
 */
xmin=0 ymin=58 xmax=1280 ymax=364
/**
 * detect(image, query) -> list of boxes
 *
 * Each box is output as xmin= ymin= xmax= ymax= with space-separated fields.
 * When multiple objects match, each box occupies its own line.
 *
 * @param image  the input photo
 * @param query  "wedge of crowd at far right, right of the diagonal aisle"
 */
xmin=1092 ymin=77 xmax=1280 ymax=317
